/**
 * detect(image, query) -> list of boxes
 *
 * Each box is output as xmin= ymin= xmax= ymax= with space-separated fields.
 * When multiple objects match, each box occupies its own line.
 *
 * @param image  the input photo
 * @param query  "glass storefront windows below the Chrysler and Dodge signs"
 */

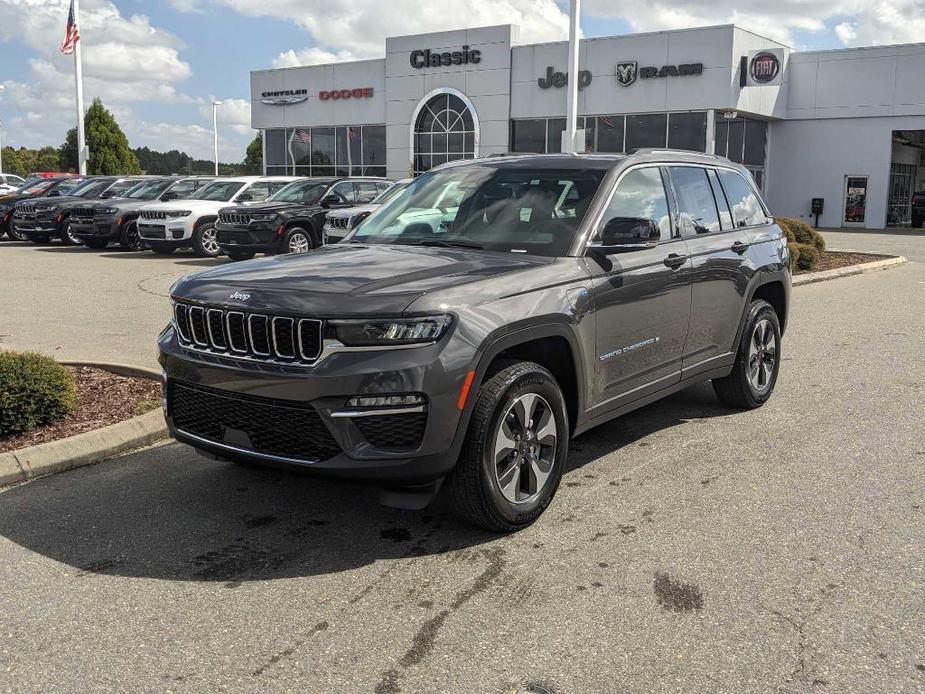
xmin=264 ymin=125 xmax=385 ymax=177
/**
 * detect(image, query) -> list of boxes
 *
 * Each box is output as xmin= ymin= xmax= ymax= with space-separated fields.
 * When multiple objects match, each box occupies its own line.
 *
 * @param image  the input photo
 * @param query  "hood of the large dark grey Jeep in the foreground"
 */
xmin=172 ymin=244 xmax=551 ymax=318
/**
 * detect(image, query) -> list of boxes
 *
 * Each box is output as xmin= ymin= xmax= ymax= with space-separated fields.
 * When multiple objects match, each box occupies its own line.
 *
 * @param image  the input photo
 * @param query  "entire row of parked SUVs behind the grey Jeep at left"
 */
xmin=0 ymin=175 xmax=404 ymax=260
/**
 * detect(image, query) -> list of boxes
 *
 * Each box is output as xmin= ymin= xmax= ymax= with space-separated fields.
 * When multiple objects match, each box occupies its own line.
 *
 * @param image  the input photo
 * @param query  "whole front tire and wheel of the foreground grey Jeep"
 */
xmin=444 ymin=362 xmax=569 ymax=532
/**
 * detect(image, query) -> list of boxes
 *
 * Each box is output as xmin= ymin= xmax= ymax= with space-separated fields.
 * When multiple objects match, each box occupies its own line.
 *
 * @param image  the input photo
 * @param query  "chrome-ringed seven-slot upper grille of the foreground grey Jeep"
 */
xmin=174 ymin=302 xmax=323 ymax=364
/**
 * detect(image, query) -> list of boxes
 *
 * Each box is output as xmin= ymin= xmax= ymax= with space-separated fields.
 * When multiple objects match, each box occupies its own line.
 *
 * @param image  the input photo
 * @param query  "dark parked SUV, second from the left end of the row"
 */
xmin=10 ymin=176 xmax=145 ymax=245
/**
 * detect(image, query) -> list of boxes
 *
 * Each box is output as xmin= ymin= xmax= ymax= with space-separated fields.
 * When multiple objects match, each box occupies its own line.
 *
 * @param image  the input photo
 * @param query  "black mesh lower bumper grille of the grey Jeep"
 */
xmin=167 ymin=380 xmax=341 ymax=462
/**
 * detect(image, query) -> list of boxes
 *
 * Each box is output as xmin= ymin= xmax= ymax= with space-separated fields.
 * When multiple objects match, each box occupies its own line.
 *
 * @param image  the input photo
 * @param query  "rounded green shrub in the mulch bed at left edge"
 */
xmin=0 ymin=352 xmax=77 ymax=438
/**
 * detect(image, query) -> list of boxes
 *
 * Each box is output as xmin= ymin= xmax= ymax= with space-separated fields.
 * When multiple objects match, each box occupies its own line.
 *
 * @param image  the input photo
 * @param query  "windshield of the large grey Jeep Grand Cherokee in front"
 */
xmin=347 ymin=163 xmax=606 ymax=256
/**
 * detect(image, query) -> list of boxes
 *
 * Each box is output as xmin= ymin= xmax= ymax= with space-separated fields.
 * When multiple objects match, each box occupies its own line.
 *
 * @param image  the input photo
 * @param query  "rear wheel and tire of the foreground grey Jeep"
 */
xmin=713 ymin=299 xmax=780 ymax=410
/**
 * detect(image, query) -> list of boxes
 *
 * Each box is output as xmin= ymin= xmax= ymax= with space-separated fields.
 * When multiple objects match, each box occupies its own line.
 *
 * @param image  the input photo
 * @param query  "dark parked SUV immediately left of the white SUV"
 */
xmin=69 ymin=176 xmax=215 ymax=251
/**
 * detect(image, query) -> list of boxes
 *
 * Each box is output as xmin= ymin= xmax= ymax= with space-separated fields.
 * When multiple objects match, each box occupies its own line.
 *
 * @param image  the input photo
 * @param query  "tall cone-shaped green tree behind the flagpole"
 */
xmin=58 ymin=98 xmax=141 ymax=176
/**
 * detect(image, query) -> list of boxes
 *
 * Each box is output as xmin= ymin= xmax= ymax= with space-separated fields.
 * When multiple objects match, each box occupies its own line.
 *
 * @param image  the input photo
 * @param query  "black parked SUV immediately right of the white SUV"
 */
xmin=215 ymin=178 xmax=392 ymax=260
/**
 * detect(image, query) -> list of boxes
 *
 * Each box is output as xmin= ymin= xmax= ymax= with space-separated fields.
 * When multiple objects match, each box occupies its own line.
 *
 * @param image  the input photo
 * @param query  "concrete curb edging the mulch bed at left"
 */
xmin=0 ymin=361 xmax=168 ymax=487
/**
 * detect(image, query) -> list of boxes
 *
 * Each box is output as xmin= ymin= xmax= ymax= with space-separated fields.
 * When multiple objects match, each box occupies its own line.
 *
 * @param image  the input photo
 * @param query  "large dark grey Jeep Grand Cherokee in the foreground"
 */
xmin=159 ymin=150 xmax=790 ymax=531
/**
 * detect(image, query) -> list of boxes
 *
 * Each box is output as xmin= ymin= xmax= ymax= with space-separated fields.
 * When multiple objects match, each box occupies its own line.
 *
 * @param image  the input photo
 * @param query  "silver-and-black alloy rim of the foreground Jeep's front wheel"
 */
xmin=494 ymin=393 xmax=559 ymax=504
